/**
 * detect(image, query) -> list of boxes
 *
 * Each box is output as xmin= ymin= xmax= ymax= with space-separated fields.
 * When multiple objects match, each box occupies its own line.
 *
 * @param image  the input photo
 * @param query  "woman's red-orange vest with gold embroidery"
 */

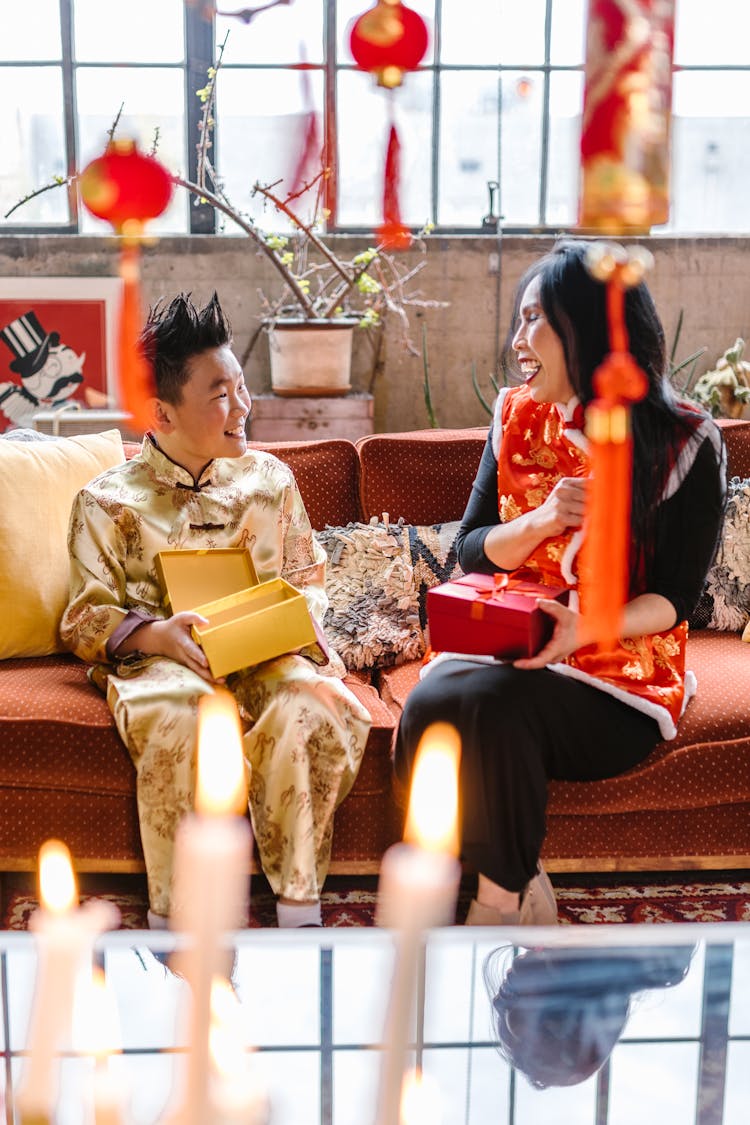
xmin=497 ymin=387 xmax=687 ymax=723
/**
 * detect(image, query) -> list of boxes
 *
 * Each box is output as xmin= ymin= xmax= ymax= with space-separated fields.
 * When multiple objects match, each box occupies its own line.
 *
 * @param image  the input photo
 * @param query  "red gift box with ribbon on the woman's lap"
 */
xmin=427 ymin=574 xmax=569 ymax=660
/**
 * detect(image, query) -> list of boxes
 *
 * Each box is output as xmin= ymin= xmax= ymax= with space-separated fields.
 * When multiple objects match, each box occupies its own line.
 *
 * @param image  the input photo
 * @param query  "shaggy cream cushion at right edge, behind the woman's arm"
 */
xmin=690 ymin=477 xmax=750 ymax=631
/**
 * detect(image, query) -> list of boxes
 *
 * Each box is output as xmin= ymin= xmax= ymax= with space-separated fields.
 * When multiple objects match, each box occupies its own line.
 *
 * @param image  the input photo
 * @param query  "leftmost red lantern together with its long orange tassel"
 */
xmin=79 ymin=140 xmax=172 ymax=431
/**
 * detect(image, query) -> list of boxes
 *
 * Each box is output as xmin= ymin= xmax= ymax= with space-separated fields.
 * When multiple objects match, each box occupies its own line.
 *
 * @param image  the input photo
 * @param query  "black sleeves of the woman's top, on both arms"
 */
xmin=455 ymin=428 xmax=726 ymax=621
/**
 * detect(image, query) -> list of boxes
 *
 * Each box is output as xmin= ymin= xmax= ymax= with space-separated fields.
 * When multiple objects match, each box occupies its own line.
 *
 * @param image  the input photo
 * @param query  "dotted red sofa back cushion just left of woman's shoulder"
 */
xmin=356 ymin=428 xmax=487 ymax=524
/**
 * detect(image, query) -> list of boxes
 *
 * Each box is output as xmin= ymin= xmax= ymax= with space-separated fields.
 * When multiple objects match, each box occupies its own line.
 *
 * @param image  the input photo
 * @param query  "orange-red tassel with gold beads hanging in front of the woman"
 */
xmin=581 ymin=244 xmax=650 ymax=649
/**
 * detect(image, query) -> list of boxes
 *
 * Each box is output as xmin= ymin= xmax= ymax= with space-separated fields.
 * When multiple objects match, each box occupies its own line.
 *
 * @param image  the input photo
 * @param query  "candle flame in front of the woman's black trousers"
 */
xmin=404 ymin=722 xmax=461 ymax=855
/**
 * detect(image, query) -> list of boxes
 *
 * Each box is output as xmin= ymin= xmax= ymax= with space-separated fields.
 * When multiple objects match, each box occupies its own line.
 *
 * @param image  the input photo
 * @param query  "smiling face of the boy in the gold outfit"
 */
xmin=156 ymin=347 xmax=250 ymax=476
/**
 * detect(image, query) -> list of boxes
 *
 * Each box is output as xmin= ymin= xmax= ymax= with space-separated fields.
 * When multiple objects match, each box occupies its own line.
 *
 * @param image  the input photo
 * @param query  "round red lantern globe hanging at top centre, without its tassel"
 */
xmin=349 ymin=0 xmax=428 ymax=89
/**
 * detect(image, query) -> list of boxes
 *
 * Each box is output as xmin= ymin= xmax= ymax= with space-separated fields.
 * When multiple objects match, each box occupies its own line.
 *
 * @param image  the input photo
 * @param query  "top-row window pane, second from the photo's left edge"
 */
xmin=73 ymin=0 xmax=184 ymax=63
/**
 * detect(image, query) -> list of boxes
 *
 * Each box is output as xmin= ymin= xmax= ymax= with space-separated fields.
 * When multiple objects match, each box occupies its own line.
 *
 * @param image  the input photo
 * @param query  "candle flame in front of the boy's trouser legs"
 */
xmin=196 ymin=690 xmax=247 ymax=817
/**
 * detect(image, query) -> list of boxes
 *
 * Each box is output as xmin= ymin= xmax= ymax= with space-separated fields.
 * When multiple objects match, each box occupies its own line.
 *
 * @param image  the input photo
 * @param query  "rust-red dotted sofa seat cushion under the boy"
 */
xmin=0 ymin=654 xmax=401 ymax=871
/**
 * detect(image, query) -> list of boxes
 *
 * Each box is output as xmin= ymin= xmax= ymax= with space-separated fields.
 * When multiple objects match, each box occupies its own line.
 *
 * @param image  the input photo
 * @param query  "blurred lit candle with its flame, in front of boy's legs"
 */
xmin=170 ymin=690 xmax=251 ymax=1125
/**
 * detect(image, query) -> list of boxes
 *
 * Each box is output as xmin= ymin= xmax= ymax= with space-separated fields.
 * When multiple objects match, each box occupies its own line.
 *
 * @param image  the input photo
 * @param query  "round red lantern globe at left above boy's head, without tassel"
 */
xmin=79 ymin=141 xmax=172 ymax=235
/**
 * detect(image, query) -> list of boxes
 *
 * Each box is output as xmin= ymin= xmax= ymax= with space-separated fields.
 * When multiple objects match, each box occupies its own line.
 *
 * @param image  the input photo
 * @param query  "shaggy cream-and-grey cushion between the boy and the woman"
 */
xmin=316 ymin=520 xmax=460 ymax=669
